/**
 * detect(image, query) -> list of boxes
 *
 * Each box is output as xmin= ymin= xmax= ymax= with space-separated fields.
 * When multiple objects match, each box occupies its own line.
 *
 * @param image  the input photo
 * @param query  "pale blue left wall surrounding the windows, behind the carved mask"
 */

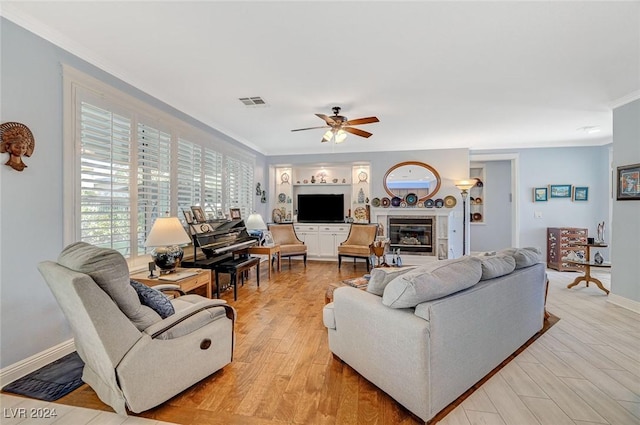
xmin=0 ymin=18 xmax=267 ymax=368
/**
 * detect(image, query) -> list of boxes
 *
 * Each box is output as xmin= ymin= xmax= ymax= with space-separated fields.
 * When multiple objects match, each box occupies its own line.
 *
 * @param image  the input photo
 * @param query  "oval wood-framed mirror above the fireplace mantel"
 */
xmin=383 ymin=161 xmax=440 ymax=202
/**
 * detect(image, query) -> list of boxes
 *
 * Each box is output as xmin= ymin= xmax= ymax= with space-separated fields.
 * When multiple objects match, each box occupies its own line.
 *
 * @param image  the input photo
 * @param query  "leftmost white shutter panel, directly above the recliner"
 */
xmin=80 ymin=102 xmax=132 ymax=255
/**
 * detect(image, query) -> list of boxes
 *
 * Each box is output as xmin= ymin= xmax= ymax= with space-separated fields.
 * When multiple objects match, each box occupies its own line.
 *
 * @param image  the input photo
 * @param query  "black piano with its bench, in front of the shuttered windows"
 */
xmin=181 ymin=219 xmax=260 ymax=300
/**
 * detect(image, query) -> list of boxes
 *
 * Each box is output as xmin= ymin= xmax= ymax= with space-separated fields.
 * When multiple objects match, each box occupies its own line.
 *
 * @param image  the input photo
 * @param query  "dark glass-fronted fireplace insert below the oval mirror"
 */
xmin=388 ymin=216 xmax=435 ymax=255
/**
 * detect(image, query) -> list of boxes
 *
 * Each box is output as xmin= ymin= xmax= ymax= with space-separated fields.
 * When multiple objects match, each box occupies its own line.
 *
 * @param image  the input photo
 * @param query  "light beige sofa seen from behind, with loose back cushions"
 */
xmin=323 ymin=249 xmax=546 ymax=421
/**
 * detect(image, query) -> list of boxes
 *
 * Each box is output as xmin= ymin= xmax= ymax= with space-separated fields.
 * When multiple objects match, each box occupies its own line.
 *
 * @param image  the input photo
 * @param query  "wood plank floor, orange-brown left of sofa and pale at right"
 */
xmin=1 ymin=261 xmax=640 ymax=425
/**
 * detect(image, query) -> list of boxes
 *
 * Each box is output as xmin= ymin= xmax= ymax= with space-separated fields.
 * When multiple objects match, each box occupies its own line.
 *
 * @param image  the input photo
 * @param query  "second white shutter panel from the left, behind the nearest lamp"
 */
xmin=136 ymin=123 xmax=171 ymax=255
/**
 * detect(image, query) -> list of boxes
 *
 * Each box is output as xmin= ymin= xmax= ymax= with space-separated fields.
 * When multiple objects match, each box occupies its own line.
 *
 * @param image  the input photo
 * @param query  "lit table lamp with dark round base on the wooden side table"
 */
xmin=144 ymin=217 xmax=191 ymax=274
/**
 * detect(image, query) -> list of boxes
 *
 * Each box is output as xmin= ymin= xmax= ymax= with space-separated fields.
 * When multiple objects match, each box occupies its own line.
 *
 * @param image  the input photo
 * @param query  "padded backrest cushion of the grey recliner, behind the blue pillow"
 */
xmin=58 ymin=242 xmax=162 ymax=330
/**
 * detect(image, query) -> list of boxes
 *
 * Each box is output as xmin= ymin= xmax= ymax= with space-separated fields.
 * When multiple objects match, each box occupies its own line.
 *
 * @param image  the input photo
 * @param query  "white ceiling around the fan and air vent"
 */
xmin=2 ymin=1 xmax=640 ymax=155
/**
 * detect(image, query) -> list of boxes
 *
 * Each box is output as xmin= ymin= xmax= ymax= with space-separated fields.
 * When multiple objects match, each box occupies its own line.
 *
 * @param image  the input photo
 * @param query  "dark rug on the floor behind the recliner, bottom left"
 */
xmin=2 ymin=351 xmax=84 ymax=401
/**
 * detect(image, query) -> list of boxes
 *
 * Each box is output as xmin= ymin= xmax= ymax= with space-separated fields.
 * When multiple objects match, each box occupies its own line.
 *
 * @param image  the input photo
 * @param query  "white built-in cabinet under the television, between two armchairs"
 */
xmin=294 ymin=223 xmax=351 ymax=259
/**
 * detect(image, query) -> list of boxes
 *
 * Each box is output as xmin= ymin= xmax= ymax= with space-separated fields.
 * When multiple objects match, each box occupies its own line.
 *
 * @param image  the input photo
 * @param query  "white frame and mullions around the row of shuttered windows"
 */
xmin=62 ymin=64 xmax=255 ymax=270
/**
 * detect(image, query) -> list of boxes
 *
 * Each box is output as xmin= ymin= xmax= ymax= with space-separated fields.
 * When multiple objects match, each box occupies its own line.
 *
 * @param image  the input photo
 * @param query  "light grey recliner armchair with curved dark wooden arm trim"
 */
xmin=38 ymin=242 xmax=236 ymax=415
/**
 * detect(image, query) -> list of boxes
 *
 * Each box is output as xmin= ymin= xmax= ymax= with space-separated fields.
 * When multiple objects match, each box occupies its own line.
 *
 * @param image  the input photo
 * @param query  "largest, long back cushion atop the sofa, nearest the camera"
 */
xmin=382 ymin=256 xmax=482 ymax=308
